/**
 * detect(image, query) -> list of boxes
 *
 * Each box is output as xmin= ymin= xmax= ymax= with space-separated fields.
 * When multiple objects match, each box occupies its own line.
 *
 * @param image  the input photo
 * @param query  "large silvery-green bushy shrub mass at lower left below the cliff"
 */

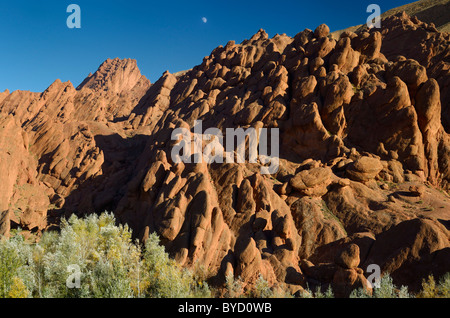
xmin=0 ymin=213 xmax=210 ymax=298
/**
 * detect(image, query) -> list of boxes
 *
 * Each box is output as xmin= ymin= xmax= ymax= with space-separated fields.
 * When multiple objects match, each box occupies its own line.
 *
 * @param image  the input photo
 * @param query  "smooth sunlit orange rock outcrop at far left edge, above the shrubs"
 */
xmin=0 ymin=114 xmax=50 ymax=236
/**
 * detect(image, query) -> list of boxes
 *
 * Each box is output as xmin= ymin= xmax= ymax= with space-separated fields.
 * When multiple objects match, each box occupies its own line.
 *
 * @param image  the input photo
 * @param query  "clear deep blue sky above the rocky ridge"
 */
xmin=0 ymin=0 xmax=411 ymax=92
